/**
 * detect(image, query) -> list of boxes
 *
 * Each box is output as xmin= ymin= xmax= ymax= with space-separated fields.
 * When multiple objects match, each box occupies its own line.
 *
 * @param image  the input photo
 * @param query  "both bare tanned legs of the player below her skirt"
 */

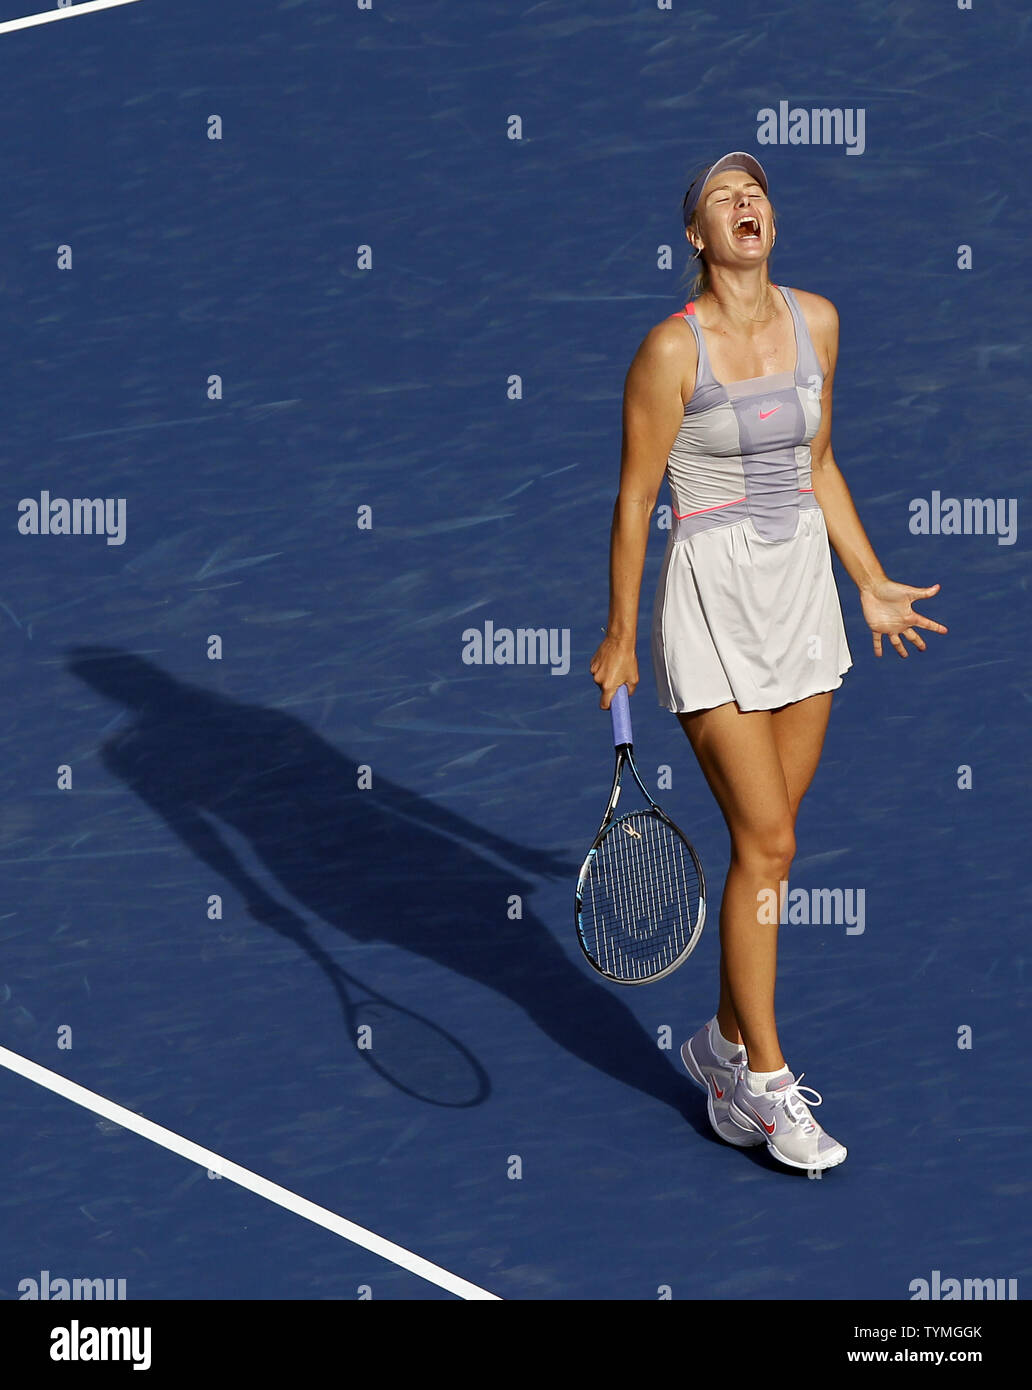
xmin=679 ymin=692 xmax=832 ymax=1072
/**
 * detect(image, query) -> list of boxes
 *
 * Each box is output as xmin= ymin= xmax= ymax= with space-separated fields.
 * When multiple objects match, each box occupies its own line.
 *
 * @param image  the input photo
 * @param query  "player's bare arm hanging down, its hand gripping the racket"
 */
xmin=591 ymin=318 xmax=697 ymax=709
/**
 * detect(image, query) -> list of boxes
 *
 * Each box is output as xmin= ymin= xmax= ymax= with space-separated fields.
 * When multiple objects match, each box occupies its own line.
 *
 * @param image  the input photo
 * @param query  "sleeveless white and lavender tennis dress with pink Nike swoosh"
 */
xmin=651 ymin=285 xmax=853 ymax=712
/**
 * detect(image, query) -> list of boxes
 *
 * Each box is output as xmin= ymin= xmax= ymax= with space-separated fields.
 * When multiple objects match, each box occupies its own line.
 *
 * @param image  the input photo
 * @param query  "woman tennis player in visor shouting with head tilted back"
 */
xmin=591 ymin=150 xmax=946 ymax=1170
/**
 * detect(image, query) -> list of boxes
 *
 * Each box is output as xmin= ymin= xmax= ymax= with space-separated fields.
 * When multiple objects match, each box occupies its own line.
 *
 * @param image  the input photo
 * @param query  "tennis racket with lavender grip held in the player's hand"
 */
xmin=577 ymin=685 xmax=707 ymax=984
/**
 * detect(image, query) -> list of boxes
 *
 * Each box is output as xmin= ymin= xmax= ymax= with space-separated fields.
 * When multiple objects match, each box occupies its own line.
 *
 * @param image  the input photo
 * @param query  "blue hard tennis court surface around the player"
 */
xmin=0 ymin=0 xmax=1032 ymax=1300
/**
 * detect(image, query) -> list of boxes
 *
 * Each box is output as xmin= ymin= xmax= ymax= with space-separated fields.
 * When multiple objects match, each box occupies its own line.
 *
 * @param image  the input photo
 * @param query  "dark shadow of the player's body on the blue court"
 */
xmin=67 ymin=648 xmax=711 ymax=1134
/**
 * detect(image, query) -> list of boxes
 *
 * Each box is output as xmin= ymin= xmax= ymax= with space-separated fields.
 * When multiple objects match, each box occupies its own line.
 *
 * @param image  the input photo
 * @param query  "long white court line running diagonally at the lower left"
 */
xmin=0 ymin=1047 xmax=502 ymax=1302
